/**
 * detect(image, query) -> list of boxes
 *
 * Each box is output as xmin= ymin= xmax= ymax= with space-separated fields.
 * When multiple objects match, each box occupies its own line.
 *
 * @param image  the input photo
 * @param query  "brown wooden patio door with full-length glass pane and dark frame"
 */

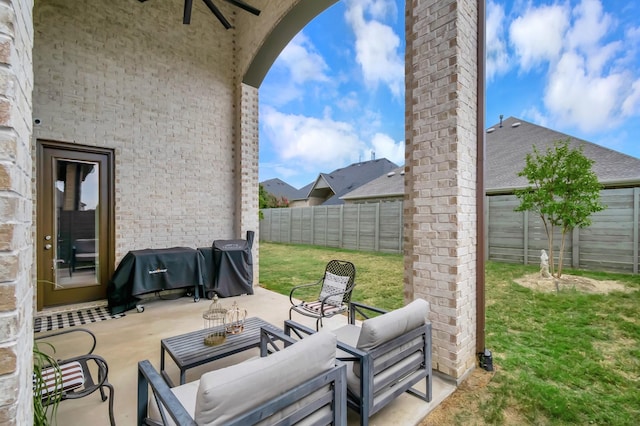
xmin=35 ymin=141 xmax=113 ymax=310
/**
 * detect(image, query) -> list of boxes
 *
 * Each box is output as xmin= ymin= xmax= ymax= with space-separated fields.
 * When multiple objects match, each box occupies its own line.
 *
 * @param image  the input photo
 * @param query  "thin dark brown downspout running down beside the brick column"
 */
xmin=476 ymin=0 xmax=493 ymax=371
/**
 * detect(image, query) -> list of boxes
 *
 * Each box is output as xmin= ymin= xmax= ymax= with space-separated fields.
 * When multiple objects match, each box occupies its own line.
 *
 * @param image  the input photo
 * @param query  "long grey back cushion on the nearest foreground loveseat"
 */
xmin=195 ymin=331 xmax=336 ymax=425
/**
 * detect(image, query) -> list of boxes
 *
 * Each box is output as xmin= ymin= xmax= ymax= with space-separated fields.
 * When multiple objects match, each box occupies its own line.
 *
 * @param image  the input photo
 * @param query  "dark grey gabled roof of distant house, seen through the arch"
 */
xmin=305 ymin=158 xmax=398 ymax=206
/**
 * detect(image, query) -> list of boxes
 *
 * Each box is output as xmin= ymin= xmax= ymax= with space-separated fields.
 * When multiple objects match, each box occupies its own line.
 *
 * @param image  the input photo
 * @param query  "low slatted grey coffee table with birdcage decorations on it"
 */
xmin=160 ymin=317 xmax=282 ymax=387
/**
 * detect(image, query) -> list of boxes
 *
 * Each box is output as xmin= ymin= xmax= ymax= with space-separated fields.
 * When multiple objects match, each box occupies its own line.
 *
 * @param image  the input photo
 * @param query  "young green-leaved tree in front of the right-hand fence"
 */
xmin=515 ymin=139 xmax=606 ymax=278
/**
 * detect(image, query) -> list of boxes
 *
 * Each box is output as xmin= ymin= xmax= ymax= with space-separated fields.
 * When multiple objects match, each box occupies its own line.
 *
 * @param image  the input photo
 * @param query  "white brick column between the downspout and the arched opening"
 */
xmin=404 ymin=0 xmax=479 ymax=379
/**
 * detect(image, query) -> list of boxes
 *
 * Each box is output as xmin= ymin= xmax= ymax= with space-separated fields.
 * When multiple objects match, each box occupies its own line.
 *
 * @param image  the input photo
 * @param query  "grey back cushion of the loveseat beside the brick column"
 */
xmin=356 ymin=299 xmax=429 ymax=351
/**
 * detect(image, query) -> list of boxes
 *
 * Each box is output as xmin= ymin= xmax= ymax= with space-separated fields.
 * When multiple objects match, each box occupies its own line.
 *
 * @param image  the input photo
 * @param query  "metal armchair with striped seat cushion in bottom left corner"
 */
xmin=34 ymin=327 xmax=115 ymax=426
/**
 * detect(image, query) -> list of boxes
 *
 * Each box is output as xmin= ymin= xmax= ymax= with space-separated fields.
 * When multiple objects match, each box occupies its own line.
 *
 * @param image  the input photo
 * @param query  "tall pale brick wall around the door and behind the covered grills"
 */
xmin=33 ymin=0 xmax=245 ymax=261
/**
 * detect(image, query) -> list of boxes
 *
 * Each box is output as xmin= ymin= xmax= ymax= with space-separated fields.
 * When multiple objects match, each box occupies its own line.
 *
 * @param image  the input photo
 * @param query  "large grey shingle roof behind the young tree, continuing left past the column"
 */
xmin=342 ymin=117 xmax=640 ymax=200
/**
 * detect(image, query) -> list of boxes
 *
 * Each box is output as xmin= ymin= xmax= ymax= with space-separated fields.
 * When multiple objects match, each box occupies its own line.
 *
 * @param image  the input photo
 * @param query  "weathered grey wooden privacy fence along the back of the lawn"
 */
xmin=260 ymin=188 xmax=640 ymax=274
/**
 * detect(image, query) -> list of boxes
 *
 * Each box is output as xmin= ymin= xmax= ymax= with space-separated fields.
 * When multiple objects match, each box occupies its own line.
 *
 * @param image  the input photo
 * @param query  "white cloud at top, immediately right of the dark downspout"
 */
xmin=486 ymin=1 xmax=509 ymax=81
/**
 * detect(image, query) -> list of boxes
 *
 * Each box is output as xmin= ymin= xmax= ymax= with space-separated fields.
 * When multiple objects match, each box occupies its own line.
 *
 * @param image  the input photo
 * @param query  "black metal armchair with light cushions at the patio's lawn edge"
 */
xmin=289 ymin=260 xmax=356 ymax=330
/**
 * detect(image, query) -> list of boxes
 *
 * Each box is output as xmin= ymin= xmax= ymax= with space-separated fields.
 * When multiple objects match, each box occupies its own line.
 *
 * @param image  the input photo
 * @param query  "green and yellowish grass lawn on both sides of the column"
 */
xmin=260 ymin=242 xmax=640 ymax=425
